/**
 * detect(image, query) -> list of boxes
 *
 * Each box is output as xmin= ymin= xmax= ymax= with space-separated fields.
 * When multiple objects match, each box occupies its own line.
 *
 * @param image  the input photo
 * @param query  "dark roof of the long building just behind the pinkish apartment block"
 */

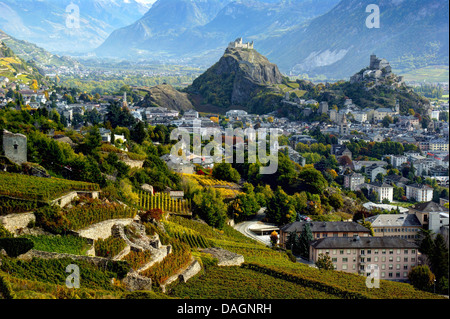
xmin=280 ymin=222 xmax=369 ymax=233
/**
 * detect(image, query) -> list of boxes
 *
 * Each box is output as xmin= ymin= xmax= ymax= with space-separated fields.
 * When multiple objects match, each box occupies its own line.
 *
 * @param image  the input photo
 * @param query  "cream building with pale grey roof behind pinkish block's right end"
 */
xmin=366 ymin=213 xmax=422 ymax=240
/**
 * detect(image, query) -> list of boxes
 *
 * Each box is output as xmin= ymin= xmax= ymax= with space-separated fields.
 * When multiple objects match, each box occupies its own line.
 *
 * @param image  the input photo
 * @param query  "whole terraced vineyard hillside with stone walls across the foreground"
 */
xmin=0 ymin=172 xmax=440 ymax=299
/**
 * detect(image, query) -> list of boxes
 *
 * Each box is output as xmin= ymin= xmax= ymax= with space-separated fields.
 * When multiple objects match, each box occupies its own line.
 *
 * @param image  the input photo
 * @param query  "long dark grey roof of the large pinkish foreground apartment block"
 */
xmin=311 ymin=237 xmax=417 ymax=249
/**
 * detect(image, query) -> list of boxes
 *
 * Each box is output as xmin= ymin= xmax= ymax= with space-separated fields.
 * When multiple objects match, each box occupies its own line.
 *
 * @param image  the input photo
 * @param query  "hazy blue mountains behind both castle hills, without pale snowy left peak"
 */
xmin=95 ymin=0 xmax=449 ymax=79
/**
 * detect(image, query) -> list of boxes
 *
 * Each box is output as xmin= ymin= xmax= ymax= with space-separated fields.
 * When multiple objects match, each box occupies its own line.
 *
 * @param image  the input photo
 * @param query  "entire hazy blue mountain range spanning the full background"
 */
xmin=0 ymin=0 xmax=449 ymax=80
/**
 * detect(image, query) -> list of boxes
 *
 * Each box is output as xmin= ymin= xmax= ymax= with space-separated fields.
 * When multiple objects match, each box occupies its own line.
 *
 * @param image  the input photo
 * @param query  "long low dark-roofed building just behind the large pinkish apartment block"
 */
xmin=280 ymin=221 xmax=370 ymax=246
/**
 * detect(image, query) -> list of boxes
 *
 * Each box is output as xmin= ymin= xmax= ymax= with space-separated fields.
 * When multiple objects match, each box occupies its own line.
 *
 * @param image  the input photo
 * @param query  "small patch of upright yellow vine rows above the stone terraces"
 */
xmin=139 ymin=192 xmax=191 ymax=214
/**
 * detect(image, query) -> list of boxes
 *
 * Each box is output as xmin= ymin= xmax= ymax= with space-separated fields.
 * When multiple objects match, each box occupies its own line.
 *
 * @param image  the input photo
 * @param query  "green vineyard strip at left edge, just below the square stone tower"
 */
xmin=0 ymin=172 xmax=100 ymax=201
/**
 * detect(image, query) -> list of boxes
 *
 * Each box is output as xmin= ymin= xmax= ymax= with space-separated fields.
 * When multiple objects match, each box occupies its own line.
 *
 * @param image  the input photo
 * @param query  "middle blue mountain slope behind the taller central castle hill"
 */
xmin=95 ymin=0 xmax=339 ymax=66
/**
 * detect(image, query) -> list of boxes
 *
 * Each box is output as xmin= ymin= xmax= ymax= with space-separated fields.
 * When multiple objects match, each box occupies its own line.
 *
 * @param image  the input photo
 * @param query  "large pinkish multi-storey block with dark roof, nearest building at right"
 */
xmin=310 ymin=236 xmax=418 ymax=280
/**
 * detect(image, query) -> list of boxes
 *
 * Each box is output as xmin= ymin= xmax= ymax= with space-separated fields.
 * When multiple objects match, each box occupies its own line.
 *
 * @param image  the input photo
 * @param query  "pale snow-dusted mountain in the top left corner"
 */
xmin=0 ymin=0 xmax=154 ymax=54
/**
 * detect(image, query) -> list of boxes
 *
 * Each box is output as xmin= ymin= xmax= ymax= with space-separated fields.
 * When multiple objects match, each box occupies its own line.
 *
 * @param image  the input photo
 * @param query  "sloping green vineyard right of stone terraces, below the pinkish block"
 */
xmin=163 ymin=217 xmax=440 ymax=299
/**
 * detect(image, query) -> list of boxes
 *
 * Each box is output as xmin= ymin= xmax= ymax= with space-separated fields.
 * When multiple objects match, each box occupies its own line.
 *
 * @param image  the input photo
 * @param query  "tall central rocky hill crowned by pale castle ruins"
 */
xmin=187 ymin=39 xmax=283 ymax=113
